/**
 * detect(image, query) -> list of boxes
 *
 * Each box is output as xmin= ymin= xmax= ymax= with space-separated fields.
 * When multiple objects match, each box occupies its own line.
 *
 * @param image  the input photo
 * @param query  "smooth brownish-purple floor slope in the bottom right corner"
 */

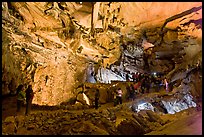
xmin=146 ymin=108 xmax=202 ymax=135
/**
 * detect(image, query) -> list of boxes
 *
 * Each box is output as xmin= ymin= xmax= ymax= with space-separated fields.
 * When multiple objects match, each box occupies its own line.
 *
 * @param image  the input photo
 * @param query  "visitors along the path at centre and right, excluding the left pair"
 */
xmin=95 ymin=72 xmax=169 ymax=109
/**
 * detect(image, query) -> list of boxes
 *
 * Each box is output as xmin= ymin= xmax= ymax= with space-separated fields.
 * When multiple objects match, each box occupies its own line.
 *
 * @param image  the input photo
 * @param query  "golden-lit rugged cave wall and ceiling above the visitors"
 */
xmin=2 ymin=2 xmax=202 ymax=105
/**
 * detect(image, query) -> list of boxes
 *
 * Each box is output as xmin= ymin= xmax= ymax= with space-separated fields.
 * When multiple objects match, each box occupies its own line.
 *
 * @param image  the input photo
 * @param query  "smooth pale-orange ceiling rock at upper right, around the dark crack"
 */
xmin=118 ymin=2 xmax=202 ymax=28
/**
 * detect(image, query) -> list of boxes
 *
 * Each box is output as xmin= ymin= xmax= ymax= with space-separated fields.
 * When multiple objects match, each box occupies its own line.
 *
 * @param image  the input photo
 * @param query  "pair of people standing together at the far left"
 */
xmin=16 ymin=84 xmax=34 ymax=115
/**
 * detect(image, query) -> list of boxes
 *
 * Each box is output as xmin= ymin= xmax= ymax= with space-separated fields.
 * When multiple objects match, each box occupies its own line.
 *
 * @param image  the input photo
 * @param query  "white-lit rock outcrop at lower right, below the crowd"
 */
xmin=131 ymin=70 xmax=198 ymax=114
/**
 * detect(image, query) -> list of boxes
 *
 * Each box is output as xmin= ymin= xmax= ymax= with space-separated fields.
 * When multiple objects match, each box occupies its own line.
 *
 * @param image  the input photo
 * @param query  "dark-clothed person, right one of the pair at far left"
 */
xmin=25 ymin=85 xmax=34 ymax=115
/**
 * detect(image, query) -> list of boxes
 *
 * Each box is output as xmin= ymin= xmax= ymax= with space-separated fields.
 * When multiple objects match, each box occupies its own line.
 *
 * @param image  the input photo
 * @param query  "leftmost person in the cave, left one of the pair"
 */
xmin=16 ymin=84 xmax=25 ymax=112
